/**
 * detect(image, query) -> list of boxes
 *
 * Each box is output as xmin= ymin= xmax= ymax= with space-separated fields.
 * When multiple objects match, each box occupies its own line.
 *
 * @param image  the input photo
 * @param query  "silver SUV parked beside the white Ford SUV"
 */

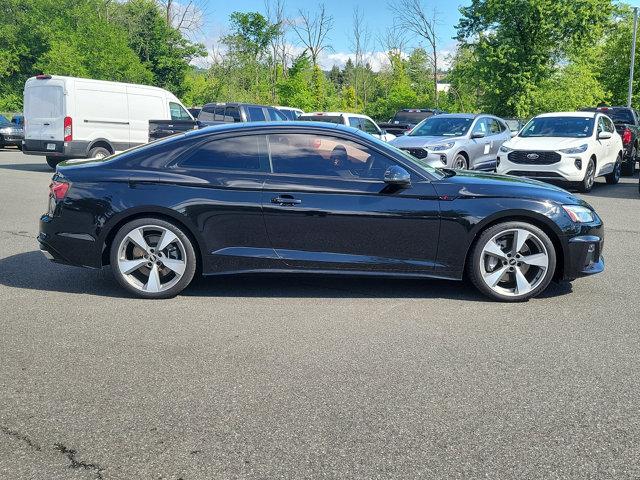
xmin=391 ymin=113 xmax=511 ymax=170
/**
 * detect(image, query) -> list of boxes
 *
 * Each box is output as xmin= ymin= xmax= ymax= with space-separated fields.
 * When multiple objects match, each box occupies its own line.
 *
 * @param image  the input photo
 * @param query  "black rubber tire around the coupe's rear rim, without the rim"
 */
xmin=109 ymin=218 xmax=197 ymax=299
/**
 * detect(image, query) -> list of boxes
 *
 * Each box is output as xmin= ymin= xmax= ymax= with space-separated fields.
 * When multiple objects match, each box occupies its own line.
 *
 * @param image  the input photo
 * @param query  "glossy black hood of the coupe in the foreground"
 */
xmin=434 ymin=169 xmax=591 ymax=208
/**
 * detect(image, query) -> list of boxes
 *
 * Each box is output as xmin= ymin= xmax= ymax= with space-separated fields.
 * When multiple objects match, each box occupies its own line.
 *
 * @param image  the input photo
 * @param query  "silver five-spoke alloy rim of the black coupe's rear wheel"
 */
xmin=117 ymin=225 xmax=187 ymax=293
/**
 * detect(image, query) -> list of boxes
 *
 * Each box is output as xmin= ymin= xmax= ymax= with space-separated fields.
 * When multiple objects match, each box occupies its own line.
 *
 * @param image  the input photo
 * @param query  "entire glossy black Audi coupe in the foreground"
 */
xmin=38 ymin=122 xmax=604 ymax=301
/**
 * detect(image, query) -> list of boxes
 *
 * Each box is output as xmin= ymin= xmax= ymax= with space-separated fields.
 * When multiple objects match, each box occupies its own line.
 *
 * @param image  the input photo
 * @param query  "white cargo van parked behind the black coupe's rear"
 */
xmin=23 ymin=75 xmax=193 ymax=168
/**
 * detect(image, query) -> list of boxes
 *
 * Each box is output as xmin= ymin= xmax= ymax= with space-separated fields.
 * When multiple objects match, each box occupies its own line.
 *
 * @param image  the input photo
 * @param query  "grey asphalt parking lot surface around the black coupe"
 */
xmin=0 ymin=150 xmax=640 ymax=480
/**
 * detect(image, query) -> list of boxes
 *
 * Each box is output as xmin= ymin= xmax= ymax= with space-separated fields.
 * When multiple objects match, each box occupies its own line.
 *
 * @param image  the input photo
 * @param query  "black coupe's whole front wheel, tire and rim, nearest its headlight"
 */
xmin=467 ymin=222 xmax=556 ymax=302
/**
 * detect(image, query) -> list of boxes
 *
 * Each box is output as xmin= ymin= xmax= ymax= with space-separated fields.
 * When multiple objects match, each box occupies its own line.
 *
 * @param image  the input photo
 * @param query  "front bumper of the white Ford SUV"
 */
xmin=496 ymin=152 xmax=589 ymax=182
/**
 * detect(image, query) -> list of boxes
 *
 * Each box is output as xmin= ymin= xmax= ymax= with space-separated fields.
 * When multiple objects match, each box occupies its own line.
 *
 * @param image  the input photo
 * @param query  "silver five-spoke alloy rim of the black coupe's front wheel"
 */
xmin=480 ymin=228 xmax=549 ymax=297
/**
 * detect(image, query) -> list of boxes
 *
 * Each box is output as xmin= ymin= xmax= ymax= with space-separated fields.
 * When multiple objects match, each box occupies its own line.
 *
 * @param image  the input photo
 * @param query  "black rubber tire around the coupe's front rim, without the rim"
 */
xmin=467 ymin=222 xmax=557 ymax=302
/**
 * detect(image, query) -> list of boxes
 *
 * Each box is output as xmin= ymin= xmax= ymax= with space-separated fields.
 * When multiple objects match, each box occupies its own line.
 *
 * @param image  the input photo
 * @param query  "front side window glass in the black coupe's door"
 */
xmin=269 ymin=133 xmax=395 ymax=181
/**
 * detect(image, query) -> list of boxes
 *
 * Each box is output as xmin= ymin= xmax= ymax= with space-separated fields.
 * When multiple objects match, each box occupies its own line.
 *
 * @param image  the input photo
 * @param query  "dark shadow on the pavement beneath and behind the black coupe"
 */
xmin=0 ymin=251 xmax=571 ymax=301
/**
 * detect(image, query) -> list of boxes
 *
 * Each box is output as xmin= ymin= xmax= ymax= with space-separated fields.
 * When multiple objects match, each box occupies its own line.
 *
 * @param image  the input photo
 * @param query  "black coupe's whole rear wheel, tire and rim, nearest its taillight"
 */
xmin=110 ymin=218 xmax=196 ymax=298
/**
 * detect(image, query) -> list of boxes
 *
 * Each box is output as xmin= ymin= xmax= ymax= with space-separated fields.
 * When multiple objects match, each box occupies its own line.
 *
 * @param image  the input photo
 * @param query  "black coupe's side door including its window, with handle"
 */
xmin=262 ymin=133 xmax=440 ymax=273
